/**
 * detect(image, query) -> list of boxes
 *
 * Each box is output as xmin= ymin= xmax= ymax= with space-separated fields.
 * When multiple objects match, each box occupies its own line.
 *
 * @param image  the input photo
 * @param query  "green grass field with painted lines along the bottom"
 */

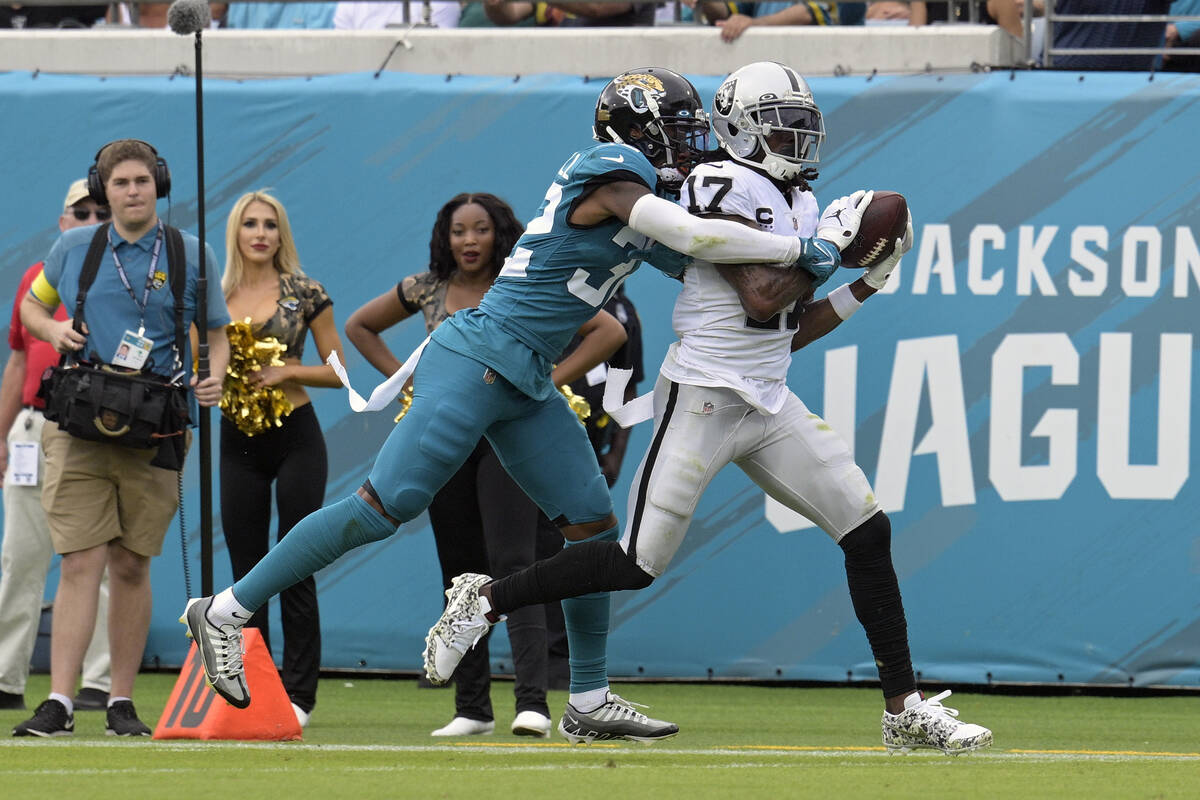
xmin=0 ymin=674 xmax=1200 ymax=800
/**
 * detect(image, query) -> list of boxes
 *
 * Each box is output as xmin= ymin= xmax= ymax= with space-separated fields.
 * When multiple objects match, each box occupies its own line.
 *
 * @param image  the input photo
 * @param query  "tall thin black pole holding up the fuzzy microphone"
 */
xmin=196 ymin=31 xmax=212 ymax=597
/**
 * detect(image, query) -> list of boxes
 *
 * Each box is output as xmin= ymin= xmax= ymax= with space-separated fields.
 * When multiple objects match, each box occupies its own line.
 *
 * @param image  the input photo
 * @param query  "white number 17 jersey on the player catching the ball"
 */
xmin=660 ymin=161 xmax=821 ymax=414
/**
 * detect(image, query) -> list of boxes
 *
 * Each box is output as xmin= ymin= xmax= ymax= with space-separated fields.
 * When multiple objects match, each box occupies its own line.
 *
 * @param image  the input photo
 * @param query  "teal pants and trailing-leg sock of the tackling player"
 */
xmin=233 ymin=342 xmax=612 ymax=610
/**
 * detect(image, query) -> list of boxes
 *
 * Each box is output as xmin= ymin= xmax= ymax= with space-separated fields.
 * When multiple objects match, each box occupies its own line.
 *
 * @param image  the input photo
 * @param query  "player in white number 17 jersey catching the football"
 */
xmin=427 ymin=61 xmax=991 ymax=753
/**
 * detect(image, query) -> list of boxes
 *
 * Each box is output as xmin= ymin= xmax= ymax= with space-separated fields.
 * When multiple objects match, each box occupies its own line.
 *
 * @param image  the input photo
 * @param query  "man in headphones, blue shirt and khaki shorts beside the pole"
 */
xmin=13 ymin=139 xmax=229 ymax=736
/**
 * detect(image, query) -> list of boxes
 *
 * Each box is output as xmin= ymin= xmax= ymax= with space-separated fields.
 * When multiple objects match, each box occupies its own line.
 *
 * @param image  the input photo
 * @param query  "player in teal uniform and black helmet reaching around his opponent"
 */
xmin=181 ymin=67 xmax=862 ymax=740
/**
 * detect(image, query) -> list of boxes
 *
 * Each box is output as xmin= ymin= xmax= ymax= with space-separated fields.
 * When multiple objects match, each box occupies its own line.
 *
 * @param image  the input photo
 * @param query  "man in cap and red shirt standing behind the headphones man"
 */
xmin=0 ymin=179 xmax=110 ymax=710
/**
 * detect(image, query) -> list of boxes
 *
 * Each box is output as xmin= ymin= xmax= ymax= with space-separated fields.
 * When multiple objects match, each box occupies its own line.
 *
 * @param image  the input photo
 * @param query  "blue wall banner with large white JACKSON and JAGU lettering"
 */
xmin=0 ymin=72 xmax=1200 ymax=686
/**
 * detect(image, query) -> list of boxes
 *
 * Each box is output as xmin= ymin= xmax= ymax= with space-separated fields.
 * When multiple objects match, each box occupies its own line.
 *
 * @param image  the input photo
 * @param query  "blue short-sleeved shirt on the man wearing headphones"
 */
xmin=35 ymin=219 xmax=229 ymax=379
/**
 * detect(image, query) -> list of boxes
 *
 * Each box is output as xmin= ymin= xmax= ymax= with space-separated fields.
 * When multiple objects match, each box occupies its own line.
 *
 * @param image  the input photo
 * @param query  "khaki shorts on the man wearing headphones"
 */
xmin=42 ymin=422 xmax=192 ymax=558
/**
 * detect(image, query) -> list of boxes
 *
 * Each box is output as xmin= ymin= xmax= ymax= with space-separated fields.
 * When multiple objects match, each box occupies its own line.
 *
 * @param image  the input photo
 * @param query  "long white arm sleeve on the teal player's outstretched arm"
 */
xmin=629 ymin=194 xmax=803 ymax=264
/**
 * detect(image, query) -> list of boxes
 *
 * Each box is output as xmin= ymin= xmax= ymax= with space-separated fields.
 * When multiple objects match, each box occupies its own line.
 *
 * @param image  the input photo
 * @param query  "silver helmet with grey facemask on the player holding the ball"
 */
xmin=713 ymin=61 xmax=824 ymax=180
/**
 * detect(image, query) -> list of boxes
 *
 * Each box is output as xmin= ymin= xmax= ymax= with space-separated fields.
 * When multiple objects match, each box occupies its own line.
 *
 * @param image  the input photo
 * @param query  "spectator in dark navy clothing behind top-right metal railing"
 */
xmin=1052 ymin=0 xmax=1172 ymax=72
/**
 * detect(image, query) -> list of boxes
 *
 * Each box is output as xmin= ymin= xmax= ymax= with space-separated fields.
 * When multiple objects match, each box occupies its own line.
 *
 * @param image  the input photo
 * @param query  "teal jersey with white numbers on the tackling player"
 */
xmin=433 ymin=143 xmax=686 ymax=399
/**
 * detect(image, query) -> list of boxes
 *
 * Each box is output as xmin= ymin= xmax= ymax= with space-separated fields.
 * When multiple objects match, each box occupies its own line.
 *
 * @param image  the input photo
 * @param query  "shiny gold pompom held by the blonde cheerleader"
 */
xmin=221 ymin=317 xmax=292 ymax=437
